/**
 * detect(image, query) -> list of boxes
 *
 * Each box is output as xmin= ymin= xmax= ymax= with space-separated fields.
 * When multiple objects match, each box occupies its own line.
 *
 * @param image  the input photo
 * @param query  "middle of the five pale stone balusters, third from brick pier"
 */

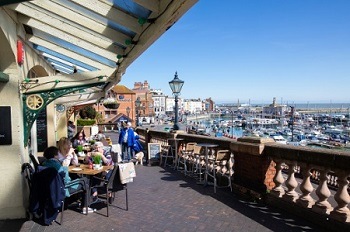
xmin=297 ymin=164 xmax=315 ymax=208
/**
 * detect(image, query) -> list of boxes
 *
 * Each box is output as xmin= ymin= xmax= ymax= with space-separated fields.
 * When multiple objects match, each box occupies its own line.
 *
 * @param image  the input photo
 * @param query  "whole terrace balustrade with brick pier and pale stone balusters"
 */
xmin=137 ymin=129 xmax=350 ymax=229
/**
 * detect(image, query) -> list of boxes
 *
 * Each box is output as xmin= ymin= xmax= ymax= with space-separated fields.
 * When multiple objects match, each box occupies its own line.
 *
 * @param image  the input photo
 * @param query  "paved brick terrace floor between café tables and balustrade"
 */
xmin=0 ymin=165 xmax=322 ymax=232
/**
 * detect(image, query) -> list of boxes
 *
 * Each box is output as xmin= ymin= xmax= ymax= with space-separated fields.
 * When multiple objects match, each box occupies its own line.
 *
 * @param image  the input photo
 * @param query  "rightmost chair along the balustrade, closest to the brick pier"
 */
xmin=212 ymin=150 xmax=233 ymax=193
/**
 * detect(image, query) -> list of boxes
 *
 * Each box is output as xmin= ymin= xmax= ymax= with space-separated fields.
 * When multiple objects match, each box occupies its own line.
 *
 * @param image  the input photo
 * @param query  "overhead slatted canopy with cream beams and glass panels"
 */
xmin=4 ymin=0 xmax=197 ymax=103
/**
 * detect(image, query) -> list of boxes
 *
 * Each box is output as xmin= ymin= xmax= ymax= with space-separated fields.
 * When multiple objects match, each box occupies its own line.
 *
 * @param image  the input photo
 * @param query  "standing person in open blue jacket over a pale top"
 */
xmin=118 ymin=122 xmax=135 ymax=162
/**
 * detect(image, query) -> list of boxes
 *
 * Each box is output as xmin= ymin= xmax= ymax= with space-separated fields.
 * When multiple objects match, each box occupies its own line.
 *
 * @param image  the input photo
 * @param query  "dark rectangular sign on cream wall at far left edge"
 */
xmin=0 ymin=106 xmax=12 ymax=145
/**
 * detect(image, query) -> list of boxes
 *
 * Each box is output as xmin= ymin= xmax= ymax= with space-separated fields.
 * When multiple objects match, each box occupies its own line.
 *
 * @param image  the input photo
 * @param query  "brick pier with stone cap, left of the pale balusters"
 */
xmin=230 ymin=137 xmax=275 ymax=193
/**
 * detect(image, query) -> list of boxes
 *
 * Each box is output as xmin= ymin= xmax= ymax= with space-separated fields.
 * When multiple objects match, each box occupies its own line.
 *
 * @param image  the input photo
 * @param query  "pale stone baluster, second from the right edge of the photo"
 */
xmin=312 ymin=167 xmax=333 ymax=214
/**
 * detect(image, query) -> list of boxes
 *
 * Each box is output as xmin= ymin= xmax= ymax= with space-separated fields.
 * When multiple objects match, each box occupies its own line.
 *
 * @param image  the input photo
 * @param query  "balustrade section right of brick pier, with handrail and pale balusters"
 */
xmin=265 ymin=144 xmax=350 ymax=223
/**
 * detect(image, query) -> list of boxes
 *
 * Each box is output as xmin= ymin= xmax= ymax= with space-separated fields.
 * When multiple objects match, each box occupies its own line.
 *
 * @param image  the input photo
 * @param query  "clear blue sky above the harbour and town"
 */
xmin=120 ymin=0 xmax=350 ymax=103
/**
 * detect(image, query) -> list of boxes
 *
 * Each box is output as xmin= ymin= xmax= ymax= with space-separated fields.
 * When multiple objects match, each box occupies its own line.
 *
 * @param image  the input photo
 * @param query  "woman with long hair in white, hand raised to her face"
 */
xmin=57 ymin=137 xmax=79 ymax=166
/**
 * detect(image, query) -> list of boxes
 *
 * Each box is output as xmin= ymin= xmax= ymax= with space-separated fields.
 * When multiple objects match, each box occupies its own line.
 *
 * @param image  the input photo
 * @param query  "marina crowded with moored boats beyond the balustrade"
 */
xmin=166 ymin=105 xmax=350 ymax=149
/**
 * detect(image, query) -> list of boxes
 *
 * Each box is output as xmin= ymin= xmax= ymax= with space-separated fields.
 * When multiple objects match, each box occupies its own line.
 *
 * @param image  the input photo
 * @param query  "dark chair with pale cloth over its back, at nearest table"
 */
xmin=90 ymin=165 xmax=128 ymax=217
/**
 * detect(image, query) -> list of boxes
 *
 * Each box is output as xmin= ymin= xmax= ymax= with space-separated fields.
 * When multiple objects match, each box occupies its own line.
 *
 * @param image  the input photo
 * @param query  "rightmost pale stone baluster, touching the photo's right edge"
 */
xmin=330 ymin=171 xmax=350 ymax=222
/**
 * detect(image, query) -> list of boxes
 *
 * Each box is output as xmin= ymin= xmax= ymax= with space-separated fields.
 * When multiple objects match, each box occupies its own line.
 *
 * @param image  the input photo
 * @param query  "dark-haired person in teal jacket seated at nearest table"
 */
xmin=43 ymin=146 xmax=90 ymax=202
